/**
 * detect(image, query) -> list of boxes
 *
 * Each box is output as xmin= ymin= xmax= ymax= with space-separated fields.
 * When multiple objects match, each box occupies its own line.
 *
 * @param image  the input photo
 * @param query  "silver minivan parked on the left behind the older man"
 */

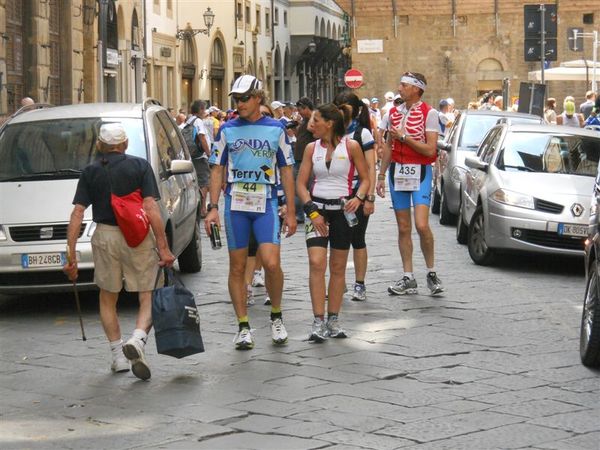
xmin=0 ymin=101 xmax=202 ymax=294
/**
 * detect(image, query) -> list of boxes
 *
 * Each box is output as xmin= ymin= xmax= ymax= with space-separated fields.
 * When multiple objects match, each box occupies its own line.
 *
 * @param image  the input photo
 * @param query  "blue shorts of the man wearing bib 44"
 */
xmin=223 ymin=194 xmax=281 ymax=250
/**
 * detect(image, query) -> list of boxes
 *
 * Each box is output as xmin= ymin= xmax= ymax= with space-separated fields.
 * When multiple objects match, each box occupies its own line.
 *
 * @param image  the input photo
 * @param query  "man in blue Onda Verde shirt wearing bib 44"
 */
xmin=204 ymin=75 xmax=296 ymax=350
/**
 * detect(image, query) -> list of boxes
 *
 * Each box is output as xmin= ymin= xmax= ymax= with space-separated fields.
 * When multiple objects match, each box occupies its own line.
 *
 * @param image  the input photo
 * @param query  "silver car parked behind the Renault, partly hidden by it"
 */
xmin=431 ymin=110 xmax=544 ymax=225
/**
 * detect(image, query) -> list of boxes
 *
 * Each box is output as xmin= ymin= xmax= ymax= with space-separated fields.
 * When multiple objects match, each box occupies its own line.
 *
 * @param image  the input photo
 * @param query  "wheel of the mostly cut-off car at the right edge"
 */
xmin=579 ymin=259 xmax=600 ymax=367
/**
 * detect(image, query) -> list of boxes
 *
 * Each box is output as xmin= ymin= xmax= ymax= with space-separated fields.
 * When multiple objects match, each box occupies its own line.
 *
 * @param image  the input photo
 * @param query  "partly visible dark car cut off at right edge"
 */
xmin=579 ymin=167 xmax=600 ymax=367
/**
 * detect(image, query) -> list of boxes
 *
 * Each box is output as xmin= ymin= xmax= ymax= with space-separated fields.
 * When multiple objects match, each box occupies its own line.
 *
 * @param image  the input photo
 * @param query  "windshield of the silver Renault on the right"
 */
xmin=497 ymin=132 xmax=600 ymax=177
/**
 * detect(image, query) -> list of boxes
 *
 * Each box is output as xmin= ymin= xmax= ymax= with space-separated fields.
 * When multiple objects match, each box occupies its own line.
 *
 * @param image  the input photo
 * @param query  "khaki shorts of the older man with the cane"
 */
xmin=92 ymin=223 xmax=162 ymax=292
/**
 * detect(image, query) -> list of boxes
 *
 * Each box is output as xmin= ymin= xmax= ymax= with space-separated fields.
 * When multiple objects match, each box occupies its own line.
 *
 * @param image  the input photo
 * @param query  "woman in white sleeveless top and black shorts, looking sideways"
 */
xmin=296 ymin=104 xmax=369 ymax=342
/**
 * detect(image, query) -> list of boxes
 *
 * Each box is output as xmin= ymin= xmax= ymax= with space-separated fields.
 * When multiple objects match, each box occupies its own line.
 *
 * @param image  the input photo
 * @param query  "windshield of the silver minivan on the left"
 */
xmin=0 ymin=117 xmax=146 ymax=182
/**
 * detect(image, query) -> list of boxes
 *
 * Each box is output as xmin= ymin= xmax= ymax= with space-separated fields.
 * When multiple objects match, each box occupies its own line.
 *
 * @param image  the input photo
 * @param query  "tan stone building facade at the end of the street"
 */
xmin=337 ymin=0 xmax=600 ymax=107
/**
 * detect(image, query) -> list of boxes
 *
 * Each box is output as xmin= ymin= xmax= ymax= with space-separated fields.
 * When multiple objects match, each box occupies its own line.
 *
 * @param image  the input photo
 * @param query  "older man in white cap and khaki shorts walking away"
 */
xmin=63 ymin=123 xmax=175 ymax=380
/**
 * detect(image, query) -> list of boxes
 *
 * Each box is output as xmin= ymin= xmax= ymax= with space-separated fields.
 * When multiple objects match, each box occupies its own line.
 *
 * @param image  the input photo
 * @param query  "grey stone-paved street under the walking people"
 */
xmin=0 ymin=201 xmax=600 ymax=450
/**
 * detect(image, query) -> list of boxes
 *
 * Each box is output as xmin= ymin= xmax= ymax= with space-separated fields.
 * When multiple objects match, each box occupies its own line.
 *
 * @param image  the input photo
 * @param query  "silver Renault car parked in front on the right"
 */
xmin=457 ymin=124 xmax=600 ymax=264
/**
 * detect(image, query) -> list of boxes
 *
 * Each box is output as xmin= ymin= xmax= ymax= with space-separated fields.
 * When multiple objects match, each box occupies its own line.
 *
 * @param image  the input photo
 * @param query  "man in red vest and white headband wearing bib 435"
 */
xmin=377 ymin=72 xmax=444 ymax=295
